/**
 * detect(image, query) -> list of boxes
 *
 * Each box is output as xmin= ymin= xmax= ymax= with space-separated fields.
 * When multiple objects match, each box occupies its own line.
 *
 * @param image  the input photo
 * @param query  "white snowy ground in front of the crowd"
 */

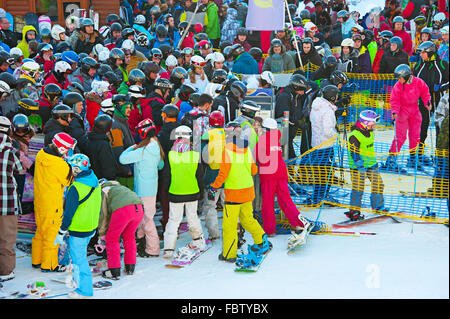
xmin=3 ymin=208 xmax=449 ymax=302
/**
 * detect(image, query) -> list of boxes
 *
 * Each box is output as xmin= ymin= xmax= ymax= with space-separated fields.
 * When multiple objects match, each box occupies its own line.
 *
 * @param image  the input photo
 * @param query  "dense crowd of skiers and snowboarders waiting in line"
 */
xmin=0 ymin=0 xmax=449 ymax=298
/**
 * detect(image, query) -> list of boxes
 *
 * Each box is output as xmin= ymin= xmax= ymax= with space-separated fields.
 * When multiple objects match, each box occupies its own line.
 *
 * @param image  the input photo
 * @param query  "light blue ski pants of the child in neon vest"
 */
xmin=69 ymin=236 xmax=94 ymax=296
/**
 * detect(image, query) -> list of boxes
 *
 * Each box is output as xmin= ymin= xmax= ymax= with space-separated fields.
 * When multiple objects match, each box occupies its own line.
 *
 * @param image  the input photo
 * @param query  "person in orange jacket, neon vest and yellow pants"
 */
xmin=208 ymin=122 xmax=271 ymax=263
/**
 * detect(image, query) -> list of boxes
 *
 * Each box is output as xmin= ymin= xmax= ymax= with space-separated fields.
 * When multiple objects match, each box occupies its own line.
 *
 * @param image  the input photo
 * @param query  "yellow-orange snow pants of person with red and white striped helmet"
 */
xmin=31 ymin=205 xmax=63 ymax=270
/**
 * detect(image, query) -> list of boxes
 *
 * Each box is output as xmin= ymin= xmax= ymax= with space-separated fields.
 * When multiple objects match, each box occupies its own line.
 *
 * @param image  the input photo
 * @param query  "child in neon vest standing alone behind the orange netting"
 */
xmin=346 ymin=110 xmax=384 ymax=220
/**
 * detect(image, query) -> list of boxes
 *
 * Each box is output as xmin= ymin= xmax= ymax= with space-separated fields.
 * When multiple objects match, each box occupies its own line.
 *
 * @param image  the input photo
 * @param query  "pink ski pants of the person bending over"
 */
xmin=105 ymin=205 xmax=144 ymax=268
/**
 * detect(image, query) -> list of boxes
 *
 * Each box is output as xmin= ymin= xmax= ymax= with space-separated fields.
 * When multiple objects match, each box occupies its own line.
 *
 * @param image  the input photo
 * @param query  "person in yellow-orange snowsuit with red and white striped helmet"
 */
xmin=31 ymin=133 xmax=75 ymax=272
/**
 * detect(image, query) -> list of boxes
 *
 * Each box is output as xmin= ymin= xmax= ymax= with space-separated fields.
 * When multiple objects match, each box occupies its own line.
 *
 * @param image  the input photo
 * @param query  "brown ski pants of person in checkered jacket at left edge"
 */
xmin=0 ymin=215 xmax=17 ymax=276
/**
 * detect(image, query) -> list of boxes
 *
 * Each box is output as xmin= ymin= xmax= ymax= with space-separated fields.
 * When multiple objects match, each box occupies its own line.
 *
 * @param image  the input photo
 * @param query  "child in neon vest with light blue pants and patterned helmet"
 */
xmin=54 ymin=154 xmax=102 ymax=298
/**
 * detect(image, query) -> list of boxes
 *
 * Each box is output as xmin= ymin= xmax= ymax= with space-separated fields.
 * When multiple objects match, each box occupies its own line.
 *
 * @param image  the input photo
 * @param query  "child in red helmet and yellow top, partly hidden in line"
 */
xmin=201 ymin=111 xmax=225 ymax=240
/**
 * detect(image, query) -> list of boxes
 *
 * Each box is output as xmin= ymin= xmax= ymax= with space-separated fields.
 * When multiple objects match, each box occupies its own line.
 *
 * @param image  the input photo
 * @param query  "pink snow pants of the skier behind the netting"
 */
xmin=389 ymin=112 xmax=422 ymax=153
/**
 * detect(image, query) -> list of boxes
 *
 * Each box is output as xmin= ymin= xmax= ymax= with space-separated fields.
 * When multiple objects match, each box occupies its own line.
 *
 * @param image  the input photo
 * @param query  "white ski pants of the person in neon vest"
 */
xmin=164 ymin=201 xmax=203 ymax=250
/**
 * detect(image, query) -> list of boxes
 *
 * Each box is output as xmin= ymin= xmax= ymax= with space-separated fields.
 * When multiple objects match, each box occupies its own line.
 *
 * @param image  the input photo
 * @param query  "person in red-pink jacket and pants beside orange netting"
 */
xmin=254 ymin=119 xmax=307 ymax=235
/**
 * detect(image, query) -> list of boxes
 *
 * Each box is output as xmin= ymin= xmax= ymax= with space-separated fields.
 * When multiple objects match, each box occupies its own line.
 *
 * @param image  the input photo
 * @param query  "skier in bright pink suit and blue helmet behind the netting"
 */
xmin=382 ymin=64 xmax=431 ymax=173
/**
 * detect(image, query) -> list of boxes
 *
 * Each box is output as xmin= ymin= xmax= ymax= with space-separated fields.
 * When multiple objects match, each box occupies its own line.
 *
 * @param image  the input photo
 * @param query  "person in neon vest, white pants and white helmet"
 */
xmin=163 ymin=125 xmax=206 ymax=258
